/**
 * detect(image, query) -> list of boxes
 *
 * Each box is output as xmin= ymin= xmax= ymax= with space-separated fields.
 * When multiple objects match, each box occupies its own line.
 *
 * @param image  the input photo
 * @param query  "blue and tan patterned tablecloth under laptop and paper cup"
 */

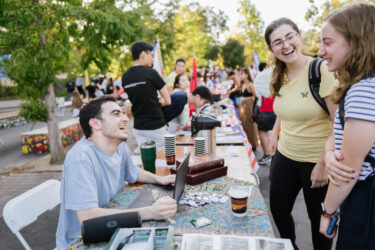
xmin=69 ymin=176 xmax=274 ymax=249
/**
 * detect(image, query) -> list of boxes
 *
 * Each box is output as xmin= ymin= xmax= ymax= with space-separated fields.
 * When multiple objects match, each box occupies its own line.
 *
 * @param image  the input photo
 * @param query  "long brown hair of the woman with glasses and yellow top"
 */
xmin=264 ymin=17 xmax=300 ymax=96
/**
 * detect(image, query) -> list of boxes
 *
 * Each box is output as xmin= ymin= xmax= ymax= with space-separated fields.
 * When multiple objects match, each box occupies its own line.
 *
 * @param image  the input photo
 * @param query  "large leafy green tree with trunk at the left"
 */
xmin=0 ymin=0 xmax=143 ymax=163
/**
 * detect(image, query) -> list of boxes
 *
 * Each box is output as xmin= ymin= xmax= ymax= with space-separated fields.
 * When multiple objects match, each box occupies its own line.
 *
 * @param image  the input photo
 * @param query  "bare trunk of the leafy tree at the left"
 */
xmin=46 ymin=84 xmax=65 ymax=164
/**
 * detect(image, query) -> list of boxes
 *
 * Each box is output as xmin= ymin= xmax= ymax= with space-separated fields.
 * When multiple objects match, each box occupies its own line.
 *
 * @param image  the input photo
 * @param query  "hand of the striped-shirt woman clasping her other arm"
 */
xmin=324 ymin=151 xmax=355 ymax=187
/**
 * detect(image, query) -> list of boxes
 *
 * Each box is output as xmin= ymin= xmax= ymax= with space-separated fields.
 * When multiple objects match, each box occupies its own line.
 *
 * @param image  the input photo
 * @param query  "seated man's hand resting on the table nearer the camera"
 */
xmin=150 ymin=196 xmax=177 ymax=220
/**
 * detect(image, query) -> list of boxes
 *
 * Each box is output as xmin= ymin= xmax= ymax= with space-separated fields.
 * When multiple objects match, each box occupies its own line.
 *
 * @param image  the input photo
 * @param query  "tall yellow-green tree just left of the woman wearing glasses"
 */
xmin=237 ymin=0 xmax=270 ymax=61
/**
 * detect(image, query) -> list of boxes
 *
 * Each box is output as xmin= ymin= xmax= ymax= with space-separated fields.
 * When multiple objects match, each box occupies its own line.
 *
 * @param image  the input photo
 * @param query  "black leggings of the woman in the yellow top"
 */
xmin=270 ymin=151 xmax=332 ymax=250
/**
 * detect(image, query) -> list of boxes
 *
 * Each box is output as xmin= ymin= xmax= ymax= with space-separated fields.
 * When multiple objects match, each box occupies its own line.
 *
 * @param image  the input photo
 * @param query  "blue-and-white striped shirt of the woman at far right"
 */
xmin=333 ymin=77 xmax=375 ymax=181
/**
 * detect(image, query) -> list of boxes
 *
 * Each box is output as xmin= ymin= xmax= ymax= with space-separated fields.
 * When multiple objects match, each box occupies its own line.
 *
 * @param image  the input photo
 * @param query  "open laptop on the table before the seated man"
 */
xmin=128 ymin=153 xmax=190 ymax=208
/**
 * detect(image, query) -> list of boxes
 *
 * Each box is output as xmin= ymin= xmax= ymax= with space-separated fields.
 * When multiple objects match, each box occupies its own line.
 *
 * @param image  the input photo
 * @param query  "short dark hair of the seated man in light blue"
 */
xmin=79 ymin=95 xmax=116 ymax=138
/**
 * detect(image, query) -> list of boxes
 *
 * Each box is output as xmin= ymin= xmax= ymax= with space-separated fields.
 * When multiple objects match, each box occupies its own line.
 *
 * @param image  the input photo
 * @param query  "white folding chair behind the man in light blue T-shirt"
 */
xmin=3 ymin=179 xmax=61 ymax=250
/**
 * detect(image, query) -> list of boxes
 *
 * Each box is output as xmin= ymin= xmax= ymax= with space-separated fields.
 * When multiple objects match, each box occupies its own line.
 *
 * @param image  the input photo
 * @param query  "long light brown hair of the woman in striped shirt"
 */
xmin=324 ymin=3 xmax=375 ymax=103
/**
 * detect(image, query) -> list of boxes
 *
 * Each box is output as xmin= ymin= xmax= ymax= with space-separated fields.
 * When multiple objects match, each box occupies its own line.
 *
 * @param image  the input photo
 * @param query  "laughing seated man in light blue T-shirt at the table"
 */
xmin=56 ymin=96 xmax=177 ymax=249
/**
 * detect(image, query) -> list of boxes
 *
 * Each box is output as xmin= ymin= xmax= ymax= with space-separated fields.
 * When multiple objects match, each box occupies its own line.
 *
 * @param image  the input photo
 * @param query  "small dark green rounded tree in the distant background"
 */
xmin=221 ymin=39 xmax=246 ymax=69
